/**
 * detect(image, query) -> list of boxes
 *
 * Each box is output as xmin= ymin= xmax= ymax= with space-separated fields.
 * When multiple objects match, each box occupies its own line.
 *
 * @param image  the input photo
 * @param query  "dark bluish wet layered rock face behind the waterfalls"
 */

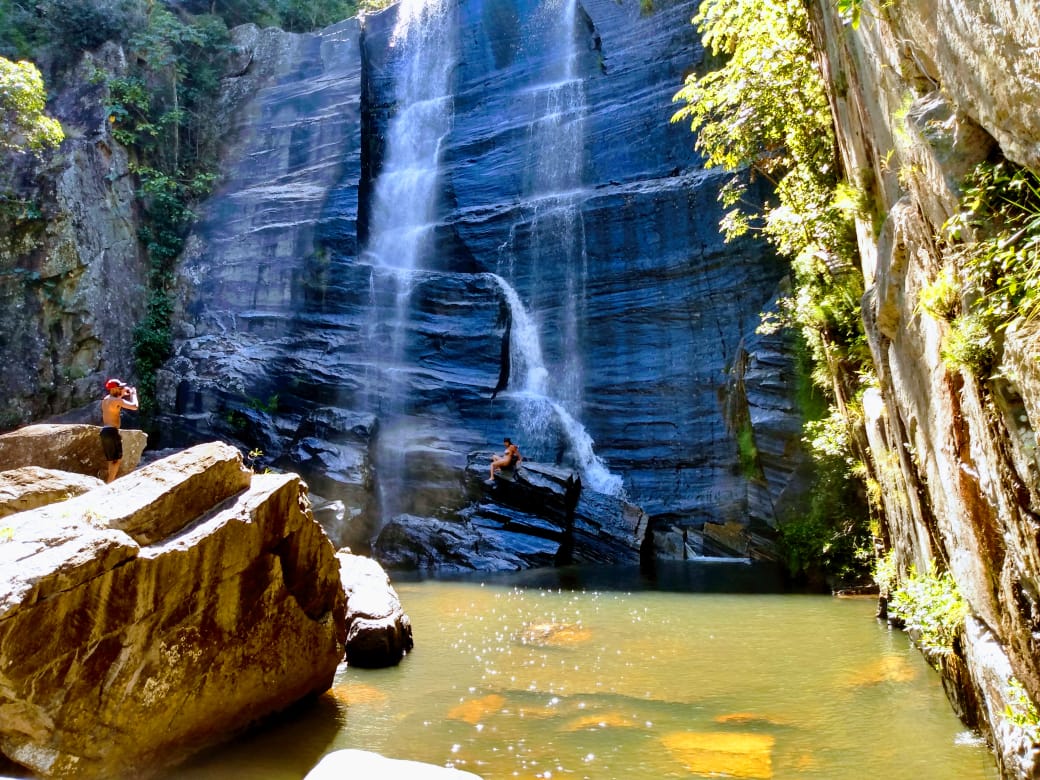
xmin=161 ymin=0 xmax=800 ymax=568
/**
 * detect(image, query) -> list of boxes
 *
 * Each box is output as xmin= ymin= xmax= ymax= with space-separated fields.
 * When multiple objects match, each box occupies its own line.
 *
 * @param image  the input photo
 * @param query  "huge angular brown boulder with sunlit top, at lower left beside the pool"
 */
xmin=0 ymin=443 xmax=345 ymax=778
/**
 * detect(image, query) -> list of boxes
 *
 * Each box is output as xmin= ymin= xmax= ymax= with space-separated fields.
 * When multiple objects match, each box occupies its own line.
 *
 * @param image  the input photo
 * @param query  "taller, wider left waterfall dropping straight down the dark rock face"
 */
xmin=362 ymin=0 xmax=458 ymax=521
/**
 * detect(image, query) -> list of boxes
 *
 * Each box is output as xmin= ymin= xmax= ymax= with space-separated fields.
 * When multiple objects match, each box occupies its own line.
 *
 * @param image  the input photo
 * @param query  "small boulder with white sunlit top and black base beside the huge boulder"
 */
xmin=336 ymin=550 xmax=414 ymax=669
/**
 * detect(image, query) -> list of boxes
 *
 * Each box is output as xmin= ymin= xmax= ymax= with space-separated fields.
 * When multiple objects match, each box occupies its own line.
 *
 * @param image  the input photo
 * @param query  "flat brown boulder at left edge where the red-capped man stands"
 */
xmin=0 ymin=424 xmax=148 ymax=478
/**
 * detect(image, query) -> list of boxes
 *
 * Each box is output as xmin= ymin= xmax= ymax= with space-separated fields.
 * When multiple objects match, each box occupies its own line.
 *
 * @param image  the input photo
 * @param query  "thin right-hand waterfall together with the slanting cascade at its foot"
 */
xmin=492 ymin=0 xmax=623 ymax=495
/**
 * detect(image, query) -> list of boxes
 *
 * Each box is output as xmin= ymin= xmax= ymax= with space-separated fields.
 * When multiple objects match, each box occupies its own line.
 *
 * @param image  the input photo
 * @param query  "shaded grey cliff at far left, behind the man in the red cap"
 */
xmin=0 ymin=45 xmax=147 ymax=431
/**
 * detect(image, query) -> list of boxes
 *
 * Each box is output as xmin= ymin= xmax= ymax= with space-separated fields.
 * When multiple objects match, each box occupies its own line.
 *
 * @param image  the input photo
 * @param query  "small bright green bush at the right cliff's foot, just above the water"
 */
xmin=888 ymin=563 xmax=968 ymax=655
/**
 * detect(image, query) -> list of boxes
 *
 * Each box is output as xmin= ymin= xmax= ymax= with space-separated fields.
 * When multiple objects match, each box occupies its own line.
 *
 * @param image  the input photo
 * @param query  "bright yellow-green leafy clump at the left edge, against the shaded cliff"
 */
xmin=0 ymin=57 xmax=64 ymax=152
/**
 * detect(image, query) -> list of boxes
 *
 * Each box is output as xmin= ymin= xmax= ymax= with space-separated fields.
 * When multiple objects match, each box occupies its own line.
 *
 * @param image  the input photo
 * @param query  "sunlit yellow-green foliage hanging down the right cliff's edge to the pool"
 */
xmin=673 ymin=0 xmax=873 ymax=580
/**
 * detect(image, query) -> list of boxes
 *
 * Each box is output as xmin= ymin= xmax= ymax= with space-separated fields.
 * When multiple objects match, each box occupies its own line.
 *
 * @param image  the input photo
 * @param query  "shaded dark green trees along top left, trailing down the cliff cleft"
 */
xmin=0 ymin=0 xmax=366 ymax=402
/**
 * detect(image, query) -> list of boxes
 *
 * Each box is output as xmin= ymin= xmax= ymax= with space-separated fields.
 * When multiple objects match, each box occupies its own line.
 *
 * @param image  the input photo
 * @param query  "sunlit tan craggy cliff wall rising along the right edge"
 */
xmin=814 ymin=0 xmax=1040 ymax=777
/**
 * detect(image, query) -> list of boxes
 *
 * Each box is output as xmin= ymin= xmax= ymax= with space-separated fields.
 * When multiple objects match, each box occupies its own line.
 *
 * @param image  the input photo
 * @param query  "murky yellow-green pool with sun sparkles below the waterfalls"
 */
xmin=173 ymin=569 xmax=998 ymax=780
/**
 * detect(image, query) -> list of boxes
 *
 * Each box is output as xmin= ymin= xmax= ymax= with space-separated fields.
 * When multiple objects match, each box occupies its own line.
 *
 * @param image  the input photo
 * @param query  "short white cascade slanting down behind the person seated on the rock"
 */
xmin=488 ymin=274 xmax=623 ymax=496
